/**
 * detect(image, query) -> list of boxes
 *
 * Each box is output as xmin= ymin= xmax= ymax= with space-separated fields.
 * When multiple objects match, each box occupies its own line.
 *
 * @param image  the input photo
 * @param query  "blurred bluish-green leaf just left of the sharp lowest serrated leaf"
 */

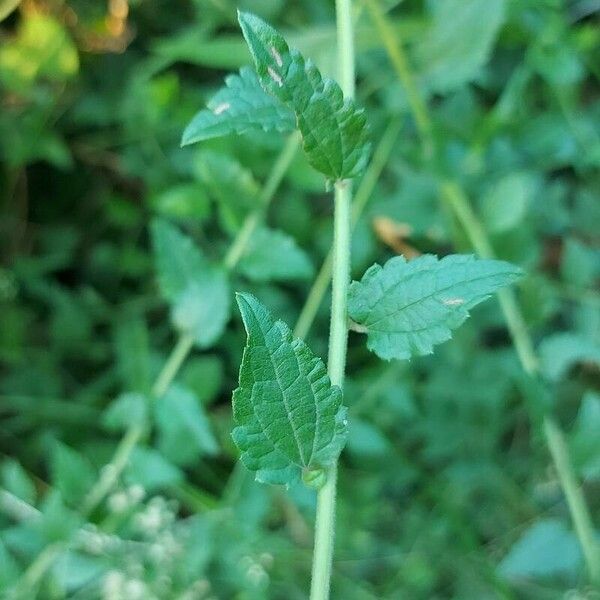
xmin=154 ymin=385 xmax=219 ymax=466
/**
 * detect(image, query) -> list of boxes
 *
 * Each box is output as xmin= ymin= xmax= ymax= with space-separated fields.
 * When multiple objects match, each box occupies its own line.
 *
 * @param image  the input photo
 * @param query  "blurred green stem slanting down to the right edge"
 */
xmin=442 ymin=182 xmax=600 ymax=585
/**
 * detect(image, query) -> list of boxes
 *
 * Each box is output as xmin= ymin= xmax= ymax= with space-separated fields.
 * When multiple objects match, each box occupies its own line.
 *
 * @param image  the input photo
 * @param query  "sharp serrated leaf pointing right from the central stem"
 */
xmin=348 ymin=254 xmax=521 ymax=360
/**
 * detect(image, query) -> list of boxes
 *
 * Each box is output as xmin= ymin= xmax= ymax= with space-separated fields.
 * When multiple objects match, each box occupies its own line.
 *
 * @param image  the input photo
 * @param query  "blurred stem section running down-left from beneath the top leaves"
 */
xmin=223 ymin=132 xmax=300 ymax=271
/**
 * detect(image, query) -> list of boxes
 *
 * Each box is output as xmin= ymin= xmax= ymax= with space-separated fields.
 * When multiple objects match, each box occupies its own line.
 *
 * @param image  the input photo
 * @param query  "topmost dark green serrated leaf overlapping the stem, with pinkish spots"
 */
xmin=238 ymin=12 xmax=370 ymax=181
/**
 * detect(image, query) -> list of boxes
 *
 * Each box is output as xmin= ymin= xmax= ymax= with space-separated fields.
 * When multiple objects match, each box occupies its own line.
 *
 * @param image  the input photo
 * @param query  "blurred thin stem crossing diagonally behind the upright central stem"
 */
xmin=294 ymin=119 xmax=401 ymax=338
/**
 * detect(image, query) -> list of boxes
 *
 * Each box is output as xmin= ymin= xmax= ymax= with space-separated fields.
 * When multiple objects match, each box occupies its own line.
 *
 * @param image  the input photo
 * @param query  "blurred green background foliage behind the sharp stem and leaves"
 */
xmin=0 ymin=0 xmax=600 ymax=600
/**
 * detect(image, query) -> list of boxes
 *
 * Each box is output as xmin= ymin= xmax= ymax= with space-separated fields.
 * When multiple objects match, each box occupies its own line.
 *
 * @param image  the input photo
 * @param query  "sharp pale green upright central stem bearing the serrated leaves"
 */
xmin=310 ymin=0 xmax=355 ymax=600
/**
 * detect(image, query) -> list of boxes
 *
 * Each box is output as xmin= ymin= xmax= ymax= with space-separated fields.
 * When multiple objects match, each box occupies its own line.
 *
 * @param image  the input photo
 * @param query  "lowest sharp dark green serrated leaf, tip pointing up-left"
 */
xmin=232 ymin=294 xmax=346 ymax=484
